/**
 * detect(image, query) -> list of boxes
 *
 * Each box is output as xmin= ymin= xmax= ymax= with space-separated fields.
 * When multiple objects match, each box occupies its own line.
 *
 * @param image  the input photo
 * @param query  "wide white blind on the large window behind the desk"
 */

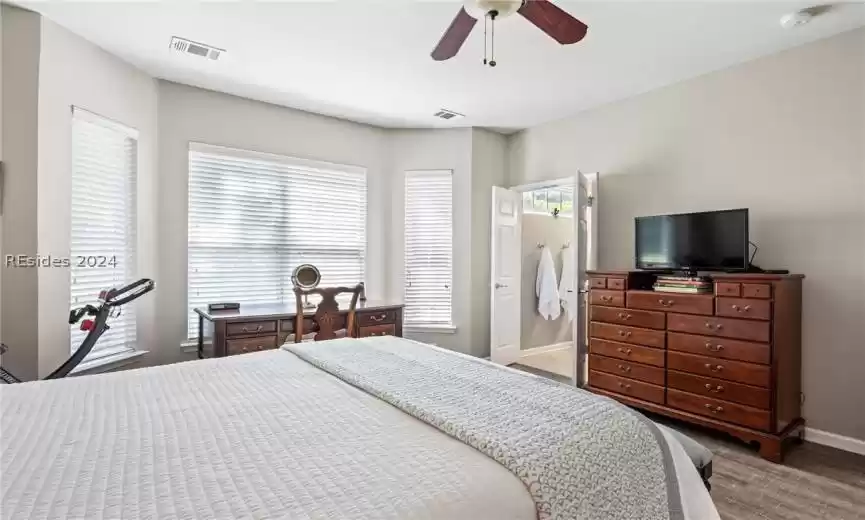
xmin=188 ymin=144 xmax=366 ymax=338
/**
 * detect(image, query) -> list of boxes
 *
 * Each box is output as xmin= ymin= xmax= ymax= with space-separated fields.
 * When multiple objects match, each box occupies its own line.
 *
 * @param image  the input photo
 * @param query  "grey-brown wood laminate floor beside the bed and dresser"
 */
xmin=514 ymin=365 xmax=865 ymax=520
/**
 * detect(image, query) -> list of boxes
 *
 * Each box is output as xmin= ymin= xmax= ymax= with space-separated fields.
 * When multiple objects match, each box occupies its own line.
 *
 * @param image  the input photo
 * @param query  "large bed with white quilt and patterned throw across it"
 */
xmin=0 ymin=338 xmax=719 ymax=520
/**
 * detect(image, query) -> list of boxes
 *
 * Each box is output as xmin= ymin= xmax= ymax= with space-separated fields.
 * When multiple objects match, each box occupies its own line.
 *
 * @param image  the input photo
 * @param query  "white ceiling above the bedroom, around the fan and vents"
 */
xmin=19 ymin=0 xmax=865 ymax=131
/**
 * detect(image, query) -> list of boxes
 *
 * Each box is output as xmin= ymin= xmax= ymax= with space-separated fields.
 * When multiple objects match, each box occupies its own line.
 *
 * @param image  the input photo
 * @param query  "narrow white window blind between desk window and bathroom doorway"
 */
xmin=404 ymin=171 xmax=453 ymax=326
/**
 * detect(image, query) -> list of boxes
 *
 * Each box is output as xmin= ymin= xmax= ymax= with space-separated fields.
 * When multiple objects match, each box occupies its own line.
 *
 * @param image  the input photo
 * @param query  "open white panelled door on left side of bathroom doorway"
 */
xmin=490 ymin=186 xmax=522 ymax=365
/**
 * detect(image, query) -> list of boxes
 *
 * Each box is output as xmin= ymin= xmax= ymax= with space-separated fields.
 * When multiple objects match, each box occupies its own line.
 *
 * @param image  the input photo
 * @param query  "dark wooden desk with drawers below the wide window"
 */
xmin=195 ymin=300 xmax=403 ymax=358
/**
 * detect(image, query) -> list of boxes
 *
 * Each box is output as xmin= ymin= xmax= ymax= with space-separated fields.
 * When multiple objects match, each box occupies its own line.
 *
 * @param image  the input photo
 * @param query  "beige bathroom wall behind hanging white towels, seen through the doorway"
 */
xmin=520 ymin=214 xmax=574 ymax=350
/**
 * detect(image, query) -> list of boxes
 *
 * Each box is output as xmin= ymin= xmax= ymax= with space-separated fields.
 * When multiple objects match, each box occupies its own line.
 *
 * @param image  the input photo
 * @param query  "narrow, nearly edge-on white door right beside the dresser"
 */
xmin=574 ymin=172 xmax=598 ymax=386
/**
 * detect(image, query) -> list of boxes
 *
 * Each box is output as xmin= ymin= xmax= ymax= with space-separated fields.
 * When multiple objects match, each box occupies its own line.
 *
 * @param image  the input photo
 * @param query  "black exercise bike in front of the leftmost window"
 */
xmin=0 ymin=278 xmax=154 ymax=383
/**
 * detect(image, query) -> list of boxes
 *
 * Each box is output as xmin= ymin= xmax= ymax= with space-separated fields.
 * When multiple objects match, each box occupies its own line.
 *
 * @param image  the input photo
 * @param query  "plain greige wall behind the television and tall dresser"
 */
xmin=509 ymin=29 xmax=865 ymax=439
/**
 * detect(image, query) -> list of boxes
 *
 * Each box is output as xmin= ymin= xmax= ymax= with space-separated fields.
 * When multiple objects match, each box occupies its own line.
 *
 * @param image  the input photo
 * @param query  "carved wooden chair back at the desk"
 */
xmin=294 ymin=284 xmax=363 ymax=343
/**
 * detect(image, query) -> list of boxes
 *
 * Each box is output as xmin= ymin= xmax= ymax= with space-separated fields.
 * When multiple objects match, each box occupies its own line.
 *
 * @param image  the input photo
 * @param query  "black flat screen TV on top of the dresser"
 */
xmin=634 ymin=209 xmax=748 ymax=271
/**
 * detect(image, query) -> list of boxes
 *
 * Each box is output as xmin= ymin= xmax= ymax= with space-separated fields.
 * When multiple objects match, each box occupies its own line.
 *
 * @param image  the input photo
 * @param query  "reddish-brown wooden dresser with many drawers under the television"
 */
xmin=588 ymin=271 xmax=804 ymax=462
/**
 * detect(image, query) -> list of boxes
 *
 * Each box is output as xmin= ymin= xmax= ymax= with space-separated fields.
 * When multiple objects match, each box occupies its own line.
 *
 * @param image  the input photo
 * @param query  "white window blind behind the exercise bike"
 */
xmin=70 ymin=108 xmax=138 ymax=360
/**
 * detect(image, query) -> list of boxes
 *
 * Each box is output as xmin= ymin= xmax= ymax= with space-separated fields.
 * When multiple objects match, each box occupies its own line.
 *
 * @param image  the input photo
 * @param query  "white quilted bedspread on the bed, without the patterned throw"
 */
xmin=0 ymin=344 xmax=718 ymax=520
